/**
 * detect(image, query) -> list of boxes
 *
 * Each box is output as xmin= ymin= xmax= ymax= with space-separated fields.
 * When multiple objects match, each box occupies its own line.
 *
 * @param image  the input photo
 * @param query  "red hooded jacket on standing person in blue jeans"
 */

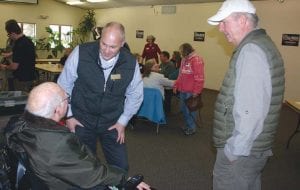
xmin=174 ymin=52 xmax=204 ymax=94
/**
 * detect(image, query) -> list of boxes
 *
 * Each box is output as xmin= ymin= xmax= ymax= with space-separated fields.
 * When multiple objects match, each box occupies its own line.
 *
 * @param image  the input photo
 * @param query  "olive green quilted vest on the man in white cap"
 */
xmin=213 ymin=29 xmax=285 ymax=151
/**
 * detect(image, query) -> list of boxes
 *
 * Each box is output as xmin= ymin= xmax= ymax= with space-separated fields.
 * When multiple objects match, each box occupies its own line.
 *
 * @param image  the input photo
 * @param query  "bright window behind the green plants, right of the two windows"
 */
xmin=49 ymin=25 xmax=73 ymax=48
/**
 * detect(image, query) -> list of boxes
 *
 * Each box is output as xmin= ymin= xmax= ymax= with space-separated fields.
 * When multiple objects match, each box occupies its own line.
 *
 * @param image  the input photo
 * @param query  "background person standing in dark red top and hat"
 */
xmin=142 ymin=35 xmax=161 ymax=63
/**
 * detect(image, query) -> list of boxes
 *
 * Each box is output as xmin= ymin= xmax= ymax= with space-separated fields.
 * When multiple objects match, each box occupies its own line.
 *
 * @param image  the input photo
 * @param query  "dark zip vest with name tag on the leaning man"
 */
xmin=71 ymin=41 xmax=136 ymax=129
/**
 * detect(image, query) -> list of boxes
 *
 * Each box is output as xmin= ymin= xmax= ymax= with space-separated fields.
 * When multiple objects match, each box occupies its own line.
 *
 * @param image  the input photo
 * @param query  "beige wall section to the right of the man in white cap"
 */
xmin=257 ymin=0 xmax=300 ymax=100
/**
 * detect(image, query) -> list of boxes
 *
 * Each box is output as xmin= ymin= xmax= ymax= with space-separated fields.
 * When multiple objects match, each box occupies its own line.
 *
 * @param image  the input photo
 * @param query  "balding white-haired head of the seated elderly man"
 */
xmin=25 ymin=82 xmax=64 ymax=119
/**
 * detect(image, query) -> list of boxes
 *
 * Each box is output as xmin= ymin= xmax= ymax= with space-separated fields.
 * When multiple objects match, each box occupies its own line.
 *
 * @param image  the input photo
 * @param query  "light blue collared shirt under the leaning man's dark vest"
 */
xmin=57 ymin=46 xmax=143 ymax=126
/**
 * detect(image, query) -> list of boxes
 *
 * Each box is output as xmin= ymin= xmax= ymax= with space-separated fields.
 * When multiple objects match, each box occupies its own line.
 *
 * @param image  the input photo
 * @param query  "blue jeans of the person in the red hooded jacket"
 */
xmin=179 ymin=92 xmax=197 ymax=129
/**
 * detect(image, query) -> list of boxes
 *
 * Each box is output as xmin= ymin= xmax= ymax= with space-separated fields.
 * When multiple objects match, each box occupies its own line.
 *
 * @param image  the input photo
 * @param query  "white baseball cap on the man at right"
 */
xmin=207 ymin=0 xmax=256 ymax=25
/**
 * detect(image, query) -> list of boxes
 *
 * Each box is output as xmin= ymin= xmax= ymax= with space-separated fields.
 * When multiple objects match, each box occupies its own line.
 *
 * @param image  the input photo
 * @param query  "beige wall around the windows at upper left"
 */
xmin=0 ymin=0 xmax=85 ymax=58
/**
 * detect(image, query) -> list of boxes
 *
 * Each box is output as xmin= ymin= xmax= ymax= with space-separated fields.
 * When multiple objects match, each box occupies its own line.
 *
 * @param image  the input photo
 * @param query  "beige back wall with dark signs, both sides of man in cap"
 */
xmin=96 ymin=0 xmax=300 ymax=99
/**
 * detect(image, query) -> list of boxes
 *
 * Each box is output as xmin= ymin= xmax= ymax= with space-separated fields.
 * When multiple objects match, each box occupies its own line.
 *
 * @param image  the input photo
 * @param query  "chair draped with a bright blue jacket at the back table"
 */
xmin=137 ymin=88 xmax=167 ymax=134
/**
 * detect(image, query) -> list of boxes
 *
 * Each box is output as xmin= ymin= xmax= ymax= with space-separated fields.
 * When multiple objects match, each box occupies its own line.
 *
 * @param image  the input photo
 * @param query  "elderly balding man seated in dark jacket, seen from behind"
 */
xmin=6 ymin=82 xmax=150 ymax=190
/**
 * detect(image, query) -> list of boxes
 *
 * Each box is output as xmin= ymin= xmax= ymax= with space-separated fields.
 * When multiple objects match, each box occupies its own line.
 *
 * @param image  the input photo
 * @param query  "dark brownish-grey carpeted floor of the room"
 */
xmin=0 ymin=89 xmax=300 ymax=190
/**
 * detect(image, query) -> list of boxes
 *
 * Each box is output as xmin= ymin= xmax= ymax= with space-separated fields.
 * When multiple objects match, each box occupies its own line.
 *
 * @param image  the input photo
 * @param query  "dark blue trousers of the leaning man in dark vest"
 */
xmin=76 ymin=126 xmax=129 ymax=172
